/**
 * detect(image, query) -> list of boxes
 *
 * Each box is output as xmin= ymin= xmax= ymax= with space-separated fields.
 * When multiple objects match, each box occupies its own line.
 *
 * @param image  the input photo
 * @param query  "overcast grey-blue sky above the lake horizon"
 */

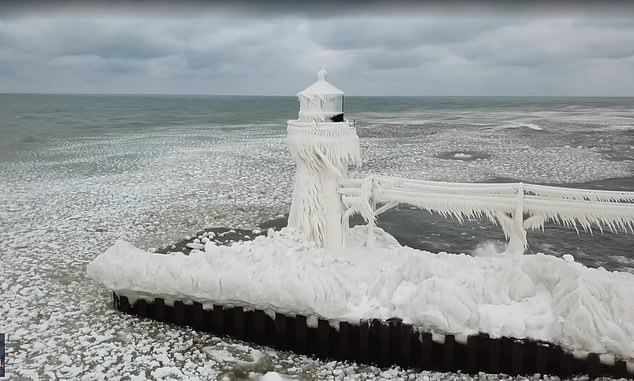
xmin=0 ymin=3 xmax=634 ymax=96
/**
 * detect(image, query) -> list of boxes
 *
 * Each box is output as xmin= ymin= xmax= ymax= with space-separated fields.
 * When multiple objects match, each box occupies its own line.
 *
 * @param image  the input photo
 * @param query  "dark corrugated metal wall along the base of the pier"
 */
xmin=113 ymin=292 xmax=634 ymax=378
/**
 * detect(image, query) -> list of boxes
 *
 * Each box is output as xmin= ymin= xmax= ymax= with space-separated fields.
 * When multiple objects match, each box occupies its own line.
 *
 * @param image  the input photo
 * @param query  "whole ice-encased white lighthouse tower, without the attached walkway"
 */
xmin=288 ymin=69 xmax=361 ymax=247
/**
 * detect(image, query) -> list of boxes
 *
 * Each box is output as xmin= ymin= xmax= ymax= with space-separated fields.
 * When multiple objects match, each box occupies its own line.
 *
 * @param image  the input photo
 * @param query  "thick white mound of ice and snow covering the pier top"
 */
xmin=88 ymin=226 xmax=634 ymax=359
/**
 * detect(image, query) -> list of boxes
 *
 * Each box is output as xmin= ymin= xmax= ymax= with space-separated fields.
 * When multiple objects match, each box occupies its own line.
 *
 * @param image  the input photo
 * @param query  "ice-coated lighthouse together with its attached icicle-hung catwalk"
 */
xmin=288 ymin=69 xmax=634 ymax=254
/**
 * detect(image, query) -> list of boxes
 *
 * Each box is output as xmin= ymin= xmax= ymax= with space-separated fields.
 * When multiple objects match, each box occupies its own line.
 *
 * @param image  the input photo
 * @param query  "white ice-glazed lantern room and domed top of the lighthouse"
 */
xmin=297 ymin=68 xmax=343 ymax=122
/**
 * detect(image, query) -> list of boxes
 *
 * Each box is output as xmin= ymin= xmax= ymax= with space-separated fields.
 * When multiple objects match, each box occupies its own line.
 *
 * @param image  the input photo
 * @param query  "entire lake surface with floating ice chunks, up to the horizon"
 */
xmin=0 ymin=95 xmax=634 ymax=379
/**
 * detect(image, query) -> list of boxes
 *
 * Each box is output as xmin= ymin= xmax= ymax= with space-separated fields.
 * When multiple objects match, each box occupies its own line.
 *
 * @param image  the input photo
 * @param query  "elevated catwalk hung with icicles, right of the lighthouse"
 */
xmin=338 ymin=176 xmax=634 ymax=254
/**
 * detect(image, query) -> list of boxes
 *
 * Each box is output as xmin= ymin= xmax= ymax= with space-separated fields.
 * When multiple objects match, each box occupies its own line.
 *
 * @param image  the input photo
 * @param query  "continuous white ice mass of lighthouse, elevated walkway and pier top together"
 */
xmin=81 ymin=71 xmax=634 ymax=374
